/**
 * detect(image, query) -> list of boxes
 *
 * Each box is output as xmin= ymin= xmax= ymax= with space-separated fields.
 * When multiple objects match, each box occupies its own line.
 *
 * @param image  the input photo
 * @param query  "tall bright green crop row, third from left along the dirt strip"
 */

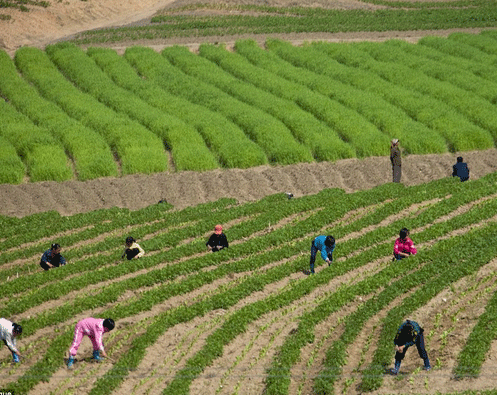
xmin=0 ymin=51 xmax=117 ymax=180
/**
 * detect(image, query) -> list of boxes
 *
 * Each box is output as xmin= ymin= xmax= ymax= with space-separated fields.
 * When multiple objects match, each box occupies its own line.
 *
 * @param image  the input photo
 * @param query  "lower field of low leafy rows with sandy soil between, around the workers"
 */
xmin=0 ymin=173 xmax=497 ymax=395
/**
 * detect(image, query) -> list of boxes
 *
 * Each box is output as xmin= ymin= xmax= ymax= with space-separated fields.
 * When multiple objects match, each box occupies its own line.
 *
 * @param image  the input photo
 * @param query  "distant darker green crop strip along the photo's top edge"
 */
xmin=68 ymin=0 xmax=497 ymax=44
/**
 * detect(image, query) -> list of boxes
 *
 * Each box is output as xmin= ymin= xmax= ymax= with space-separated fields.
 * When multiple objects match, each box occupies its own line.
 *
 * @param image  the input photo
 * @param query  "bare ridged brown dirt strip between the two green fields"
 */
xmin=0 ymin=149 xmax=497 ymax=217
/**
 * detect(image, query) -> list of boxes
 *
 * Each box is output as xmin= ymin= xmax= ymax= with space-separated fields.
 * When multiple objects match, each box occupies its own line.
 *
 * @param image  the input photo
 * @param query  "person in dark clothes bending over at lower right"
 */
xmin=390 ymin=320 xmax=431 ymax=375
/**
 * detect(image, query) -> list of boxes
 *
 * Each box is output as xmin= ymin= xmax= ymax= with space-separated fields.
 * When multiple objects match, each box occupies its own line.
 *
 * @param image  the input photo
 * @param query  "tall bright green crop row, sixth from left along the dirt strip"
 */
xmin=87 ymin=48 xmax=267 ymax=168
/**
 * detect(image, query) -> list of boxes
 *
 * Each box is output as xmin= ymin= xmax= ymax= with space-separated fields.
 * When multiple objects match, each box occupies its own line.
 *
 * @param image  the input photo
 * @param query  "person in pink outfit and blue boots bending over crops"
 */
xmin=67 ymin=317 xmax=115 ymax=369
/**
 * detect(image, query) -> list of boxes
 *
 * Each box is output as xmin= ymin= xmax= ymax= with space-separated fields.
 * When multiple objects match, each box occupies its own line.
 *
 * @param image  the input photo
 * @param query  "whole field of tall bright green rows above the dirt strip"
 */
xmin=0 ymin=30 xmax=497 ymax=184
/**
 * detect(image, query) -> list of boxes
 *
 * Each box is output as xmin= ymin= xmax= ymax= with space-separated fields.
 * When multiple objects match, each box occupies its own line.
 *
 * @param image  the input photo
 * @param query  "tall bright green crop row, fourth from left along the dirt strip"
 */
xmin=15 ymin=47 xmax=167 ymax=174
